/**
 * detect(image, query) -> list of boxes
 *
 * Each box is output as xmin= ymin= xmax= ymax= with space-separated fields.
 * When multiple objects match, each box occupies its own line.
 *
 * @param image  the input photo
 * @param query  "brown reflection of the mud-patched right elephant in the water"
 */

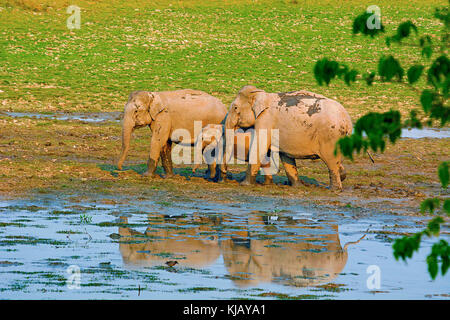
xmin=220 ymin=216 xmax=348 ymax=287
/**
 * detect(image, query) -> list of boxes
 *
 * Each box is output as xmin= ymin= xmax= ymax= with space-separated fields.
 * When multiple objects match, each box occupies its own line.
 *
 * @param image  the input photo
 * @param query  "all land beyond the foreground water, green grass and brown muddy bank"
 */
xmin=0 ymin=0 xmax=450 ymax=213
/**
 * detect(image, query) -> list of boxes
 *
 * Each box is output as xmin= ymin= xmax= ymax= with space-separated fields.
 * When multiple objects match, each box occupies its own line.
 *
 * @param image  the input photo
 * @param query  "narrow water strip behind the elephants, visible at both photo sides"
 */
xmin=0 ymin=112 xmax=450 ymax=139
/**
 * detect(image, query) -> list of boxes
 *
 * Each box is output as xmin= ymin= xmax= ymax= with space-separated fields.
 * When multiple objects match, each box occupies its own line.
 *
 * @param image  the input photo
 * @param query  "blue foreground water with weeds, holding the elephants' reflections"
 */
xmin=0 ymin=195 xmax=450 ymax=299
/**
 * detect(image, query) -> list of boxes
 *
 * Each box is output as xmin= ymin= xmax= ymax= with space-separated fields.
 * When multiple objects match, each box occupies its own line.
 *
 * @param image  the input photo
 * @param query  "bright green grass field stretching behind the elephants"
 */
xmin=0 ymin=0 xmax=446 ymax=120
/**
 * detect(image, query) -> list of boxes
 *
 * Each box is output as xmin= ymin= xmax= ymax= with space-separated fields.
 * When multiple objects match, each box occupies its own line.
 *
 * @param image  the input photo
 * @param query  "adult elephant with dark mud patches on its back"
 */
xmin=225 ymin=86 xmax=353 ymax=189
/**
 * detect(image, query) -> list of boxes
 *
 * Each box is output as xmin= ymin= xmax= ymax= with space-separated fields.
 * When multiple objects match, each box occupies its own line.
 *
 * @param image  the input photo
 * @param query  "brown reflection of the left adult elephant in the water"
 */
xmin=119 ymin=215 xmax=220 ymax=267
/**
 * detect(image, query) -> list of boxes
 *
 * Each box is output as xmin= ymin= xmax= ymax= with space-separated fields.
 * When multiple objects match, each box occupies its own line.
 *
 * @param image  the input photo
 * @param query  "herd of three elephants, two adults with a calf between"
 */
xmin=118 ymin=85 xmax=353 ymax=190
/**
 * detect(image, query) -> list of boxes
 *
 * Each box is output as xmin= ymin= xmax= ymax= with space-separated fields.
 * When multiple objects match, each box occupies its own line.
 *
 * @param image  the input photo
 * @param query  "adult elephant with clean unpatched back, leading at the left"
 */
xmin=118 ymin=89 xmax=227 ymax=177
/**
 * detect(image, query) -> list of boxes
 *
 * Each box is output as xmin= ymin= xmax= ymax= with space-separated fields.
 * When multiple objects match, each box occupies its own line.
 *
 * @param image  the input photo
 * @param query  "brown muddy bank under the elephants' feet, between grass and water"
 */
xmin=0 ymin=115 xmax=450 ymax=215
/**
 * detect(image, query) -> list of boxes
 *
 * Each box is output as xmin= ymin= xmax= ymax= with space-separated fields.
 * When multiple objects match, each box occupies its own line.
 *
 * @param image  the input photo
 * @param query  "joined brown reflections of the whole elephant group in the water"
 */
xmin=119 ymin=215 xmax=356 ymax=286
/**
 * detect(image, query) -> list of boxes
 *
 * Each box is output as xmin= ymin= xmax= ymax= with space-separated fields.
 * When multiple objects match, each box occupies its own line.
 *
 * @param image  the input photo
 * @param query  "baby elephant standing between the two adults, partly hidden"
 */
xmin=192 ymin=124 xmax=273 ymax=184
